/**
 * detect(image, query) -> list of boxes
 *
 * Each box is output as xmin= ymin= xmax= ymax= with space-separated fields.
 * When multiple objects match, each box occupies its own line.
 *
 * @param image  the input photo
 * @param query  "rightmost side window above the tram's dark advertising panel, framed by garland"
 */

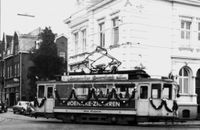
xmin=115 ymin=84 xmax=135 ymax=98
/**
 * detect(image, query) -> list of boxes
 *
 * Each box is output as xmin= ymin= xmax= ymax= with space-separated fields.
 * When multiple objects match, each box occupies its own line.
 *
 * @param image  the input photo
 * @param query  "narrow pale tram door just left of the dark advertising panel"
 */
xmin=45 ymin=85 xmax=55 ymax=113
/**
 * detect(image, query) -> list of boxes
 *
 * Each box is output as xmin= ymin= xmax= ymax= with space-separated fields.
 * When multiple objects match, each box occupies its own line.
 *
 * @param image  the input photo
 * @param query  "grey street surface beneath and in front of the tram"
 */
xmin=0 ymin=111 xmax=200 ymax=130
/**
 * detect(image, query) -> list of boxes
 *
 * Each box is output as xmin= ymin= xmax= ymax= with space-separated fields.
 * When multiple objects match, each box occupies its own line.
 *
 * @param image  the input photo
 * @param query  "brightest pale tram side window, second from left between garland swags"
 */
xmin=74 ymin=84 xmax=92 ymax=98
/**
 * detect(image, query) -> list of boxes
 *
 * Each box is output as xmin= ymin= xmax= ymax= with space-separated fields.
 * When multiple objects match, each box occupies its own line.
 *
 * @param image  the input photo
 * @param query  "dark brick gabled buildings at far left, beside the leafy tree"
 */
xmin=1 ymin=30 xmax=38 ymax=106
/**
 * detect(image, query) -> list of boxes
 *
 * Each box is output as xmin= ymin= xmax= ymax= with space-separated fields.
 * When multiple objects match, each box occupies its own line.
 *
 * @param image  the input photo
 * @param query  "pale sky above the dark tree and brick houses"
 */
xmin=0 ymin=0 xmax=76 ymax=37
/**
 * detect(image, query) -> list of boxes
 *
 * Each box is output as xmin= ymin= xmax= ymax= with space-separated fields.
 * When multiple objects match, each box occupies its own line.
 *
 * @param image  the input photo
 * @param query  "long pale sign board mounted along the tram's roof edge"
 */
xmin=61 ymin=74 xmax=128 ymax=81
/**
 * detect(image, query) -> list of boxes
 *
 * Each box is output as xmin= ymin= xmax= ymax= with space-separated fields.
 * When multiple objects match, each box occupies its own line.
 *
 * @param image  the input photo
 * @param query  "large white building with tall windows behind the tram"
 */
xmin=65 ymin=0 xmax=200 ymax=118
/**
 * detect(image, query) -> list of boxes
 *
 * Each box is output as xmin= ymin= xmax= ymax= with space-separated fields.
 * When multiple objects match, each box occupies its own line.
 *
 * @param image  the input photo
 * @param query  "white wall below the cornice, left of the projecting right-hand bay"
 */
xmin=69 ymin=0 xmax=172 ymax=76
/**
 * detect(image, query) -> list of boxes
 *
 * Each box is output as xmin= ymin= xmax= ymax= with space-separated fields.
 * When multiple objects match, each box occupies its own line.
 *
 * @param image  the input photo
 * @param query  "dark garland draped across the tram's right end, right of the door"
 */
xmin=149 ymin=98 xmax=178 ymax=112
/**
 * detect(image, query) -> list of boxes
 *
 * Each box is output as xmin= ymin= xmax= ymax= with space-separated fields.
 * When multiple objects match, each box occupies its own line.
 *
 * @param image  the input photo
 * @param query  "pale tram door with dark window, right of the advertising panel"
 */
xmin=137 ymin=84 xmax=149 ymax=116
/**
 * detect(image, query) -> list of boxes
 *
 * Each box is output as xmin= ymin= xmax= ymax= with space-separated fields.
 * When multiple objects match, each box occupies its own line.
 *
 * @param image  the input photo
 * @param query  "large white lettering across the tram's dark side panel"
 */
xmin=67 ymin=101 xmax=121 ymax=107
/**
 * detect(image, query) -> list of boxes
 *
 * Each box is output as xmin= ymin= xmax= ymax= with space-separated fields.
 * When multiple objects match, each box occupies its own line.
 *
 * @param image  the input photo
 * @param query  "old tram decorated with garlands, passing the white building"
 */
xmin=33 ymin=70 xmax=179 ymax=124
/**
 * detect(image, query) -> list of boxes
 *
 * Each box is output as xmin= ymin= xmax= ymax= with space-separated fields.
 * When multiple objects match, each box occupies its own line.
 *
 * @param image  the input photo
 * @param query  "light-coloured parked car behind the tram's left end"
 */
xmin=13 ymin=101 xmax=32 ymax=114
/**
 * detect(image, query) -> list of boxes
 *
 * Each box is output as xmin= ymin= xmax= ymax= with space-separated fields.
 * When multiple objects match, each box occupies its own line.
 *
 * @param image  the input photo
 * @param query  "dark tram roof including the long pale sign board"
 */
xmin=37 ymin=70 xmax=175 ymax=84
